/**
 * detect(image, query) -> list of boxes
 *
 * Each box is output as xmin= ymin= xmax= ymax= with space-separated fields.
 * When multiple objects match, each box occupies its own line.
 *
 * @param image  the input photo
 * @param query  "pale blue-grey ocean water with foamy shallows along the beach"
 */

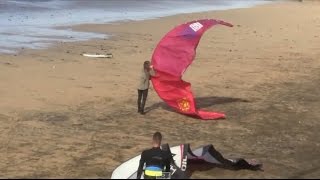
xmin=0 ymin=0 xmax=272 ymax=53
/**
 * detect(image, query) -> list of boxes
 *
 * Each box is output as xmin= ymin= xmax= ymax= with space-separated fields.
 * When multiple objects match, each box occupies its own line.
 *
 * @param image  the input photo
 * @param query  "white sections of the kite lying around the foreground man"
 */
xmin=111 ymin=146 xmax=181 ymax=179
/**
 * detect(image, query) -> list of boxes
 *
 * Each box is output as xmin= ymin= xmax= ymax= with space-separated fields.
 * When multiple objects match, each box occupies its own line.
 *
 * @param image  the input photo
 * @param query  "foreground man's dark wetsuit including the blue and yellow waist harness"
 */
xmin=137 ymin=148 xmax=171 ymax=179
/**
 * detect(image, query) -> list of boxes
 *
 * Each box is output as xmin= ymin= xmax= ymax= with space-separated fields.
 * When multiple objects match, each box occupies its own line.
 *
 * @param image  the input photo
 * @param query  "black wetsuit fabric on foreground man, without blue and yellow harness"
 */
xmin=137 ymin=147 xmax=172 ymax=179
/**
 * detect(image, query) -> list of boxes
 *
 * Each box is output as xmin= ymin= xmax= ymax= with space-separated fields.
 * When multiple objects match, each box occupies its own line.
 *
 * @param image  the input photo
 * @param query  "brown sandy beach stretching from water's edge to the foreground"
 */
xmin=0 ymin=1 xmax=320 ymax=178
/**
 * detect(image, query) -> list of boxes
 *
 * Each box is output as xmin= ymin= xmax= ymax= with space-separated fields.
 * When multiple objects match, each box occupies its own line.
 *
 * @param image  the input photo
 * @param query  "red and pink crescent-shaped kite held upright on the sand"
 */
xmin=151 ymin=19 xmax=233 ymax=120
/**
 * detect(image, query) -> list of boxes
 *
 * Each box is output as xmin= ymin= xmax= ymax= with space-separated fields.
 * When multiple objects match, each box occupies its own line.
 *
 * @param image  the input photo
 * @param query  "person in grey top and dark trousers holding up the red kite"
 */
xmin=138 ymin=61 xmax=155 ymax=114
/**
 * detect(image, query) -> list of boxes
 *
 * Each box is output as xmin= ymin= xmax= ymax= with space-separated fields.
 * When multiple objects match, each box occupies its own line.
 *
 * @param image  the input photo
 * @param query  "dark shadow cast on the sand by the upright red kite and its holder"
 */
xmin=145 ymin=96 xmax=250 ymax=113
